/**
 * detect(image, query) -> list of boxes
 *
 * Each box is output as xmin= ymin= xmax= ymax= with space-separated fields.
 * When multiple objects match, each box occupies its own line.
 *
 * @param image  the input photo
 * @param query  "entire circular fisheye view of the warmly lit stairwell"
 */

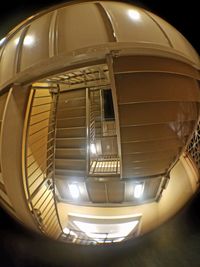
xmin=0 ymin=1 xmax=200 ymax=249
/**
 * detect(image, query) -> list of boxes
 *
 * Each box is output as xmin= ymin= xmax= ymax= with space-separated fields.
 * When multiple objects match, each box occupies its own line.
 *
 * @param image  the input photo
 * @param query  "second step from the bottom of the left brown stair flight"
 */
xmin=55 ymin=159 xmax=86 ymax=171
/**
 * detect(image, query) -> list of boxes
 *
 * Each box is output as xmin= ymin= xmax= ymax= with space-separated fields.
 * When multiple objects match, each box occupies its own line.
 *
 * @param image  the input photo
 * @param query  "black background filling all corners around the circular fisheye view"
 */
xmin=0 ymin=0 xmax=200 ymax=267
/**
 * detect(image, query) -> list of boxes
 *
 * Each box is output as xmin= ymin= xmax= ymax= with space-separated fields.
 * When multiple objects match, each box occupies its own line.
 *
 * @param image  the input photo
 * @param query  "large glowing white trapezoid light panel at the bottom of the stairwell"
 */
xmin=74 ymin=220 xmax=139 ymax=243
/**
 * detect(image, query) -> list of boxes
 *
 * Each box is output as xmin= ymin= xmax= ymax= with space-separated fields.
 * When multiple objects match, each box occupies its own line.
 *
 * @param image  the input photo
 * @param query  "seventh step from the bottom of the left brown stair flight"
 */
xmin=57 ymin=106 xmax=86 ymax=119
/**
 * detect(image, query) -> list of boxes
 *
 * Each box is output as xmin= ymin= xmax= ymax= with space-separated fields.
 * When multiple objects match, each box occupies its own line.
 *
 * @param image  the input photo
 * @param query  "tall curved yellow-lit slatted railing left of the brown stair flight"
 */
xmin=24 ymin=86 xmax=62 ymax=238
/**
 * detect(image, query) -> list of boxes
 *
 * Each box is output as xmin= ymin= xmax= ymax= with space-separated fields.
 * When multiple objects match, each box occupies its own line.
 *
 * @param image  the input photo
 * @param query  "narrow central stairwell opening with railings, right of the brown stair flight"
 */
xmin=87 ymin=88 xmax=120 ymax=176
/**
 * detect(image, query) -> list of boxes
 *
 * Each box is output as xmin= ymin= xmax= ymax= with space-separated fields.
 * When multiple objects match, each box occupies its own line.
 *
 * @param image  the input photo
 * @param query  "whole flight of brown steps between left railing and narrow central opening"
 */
xmin=55 ymin=89 xmax=87 ymax=180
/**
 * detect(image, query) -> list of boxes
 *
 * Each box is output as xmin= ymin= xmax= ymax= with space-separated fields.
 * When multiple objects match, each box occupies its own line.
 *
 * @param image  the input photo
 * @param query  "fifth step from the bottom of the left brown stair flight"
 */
xmin=56 ymin=127 xmax=86 ymax=138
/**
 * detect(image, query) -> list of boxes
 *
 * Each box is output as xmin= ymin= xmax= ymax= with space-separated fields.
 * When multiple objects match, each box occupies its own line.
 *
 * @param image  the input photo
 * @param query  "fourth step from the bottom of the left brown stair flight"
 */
xmin=56 ymin=137 xmax=86 ymax=149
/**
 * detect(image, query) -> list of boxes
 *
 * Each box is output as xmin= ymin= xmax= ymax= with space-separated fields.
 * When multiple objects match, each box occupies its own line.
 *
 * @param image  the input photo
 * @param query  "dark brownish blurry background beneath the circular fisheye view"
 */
xmin=0 ymin=194 xmax=200 ymax=267
